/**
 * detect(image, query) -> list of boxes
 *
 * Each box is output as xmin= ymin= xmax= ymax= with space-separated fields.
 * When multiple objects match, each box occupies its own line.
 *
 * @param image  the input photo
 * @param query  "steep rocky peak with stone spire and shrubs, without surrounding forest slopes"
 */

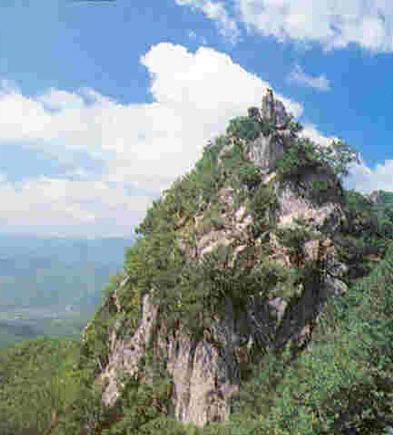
xmin=80 ymin=90 xmax=346 ymax=427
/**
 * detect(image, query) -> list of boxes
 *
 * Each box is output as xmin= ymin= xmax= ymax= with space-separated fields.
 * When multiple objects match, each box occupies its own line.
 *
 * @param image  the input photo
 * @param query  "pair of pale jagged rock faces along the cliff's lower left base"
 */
xmin=100 ymin=295 xmax=239 ymax=427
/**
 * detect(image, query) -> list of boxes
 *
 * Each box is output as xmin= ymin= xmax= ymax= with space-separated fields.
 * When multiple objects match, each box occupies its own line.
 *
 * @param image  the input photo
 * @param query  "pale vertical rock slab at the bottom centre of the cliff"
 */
xmin=162 ymin=303 xmax=240 ymax=427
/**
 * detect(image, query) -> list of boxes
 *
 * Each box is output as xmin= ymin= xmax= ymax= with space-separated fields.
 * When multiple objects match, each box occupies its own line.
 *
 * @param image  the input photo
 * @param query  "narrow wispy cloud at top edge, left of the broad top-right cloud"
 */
xmin=175 ymin=0 xmax=240 ymax=44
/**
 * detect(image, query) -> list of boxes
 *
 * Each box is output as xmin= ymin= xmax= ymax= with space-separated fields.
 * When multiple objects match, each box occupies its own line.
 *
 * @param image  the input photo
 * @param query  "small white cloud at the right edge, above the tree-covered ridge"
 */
xmin=345 ymin=160 xmax=393 ymax=193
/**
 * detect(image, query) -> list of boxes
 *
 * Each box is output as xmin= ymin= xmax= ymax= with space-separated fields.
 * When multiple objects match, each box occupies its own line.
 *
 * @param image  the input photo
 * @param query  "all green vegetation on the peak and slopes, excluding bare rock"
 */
xmin=0 ymin=100 xmax=393 ymax=435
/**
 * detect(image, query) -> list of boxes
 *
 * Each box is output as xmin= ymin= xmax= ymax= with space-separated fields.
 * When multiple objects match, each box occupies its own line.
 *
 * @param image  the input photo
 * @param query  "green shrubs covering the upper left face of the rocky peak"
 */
xmin=107 ymin=117 xmax=274 ymax=342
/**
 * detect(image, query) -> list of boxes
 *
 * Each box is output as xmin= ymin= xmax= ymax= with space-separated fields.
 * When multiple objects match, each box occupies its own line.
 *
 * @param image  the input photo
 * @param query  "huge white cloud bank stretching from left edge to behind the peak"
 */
xmin=0 ymin=43 xmax=302 ymax=234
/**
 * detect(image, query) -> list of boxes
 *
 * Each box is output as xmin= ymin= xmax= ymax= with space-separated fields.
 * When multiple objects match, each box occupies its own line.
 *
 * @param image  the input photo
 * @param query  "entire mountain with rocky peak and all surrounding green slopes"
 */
xmin=0 ymin=92 xmax=393 ymax=435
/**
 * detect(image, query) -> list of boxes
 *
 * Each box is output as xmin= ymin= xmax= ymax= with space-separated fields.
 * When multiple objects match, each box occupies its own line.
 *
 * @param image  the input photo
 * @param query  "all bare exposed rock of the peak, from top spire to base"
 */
xmin=87 ymin=88 xmax=346 ymax=427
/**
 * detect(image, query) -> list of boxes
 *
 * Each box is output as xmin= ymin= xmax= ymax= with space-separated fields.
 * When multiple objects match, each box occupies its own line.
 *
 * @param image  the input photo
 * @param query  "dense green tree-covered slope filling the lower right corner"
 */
xmin=230 ymin=244 xmax=393 ymax=434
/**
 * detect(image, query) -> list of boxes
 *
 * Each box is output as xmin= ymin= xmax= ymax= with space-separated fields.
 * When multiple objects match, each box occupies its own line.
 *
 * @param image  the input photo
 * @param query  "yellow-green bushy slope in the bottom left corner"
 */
xmin=0 ymin=339 xmax=80 ymax=435
